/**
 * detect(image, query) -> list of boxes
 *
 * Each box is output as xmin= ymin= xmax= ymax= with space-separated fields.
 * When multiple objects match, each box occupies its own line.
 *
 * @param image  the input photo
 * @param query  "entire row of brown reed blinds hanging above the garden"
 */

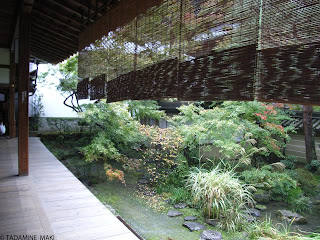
xmin=79 ymin=0 xmax=320 ymax=104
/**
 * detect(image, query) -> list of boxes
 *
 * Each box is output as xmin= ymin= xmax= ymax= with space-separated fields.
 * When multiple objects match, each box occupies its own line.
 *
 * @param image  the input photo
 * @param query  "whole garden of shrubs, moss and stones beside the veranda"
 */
xmin=40 ymin=100 xmax=320 ymax=240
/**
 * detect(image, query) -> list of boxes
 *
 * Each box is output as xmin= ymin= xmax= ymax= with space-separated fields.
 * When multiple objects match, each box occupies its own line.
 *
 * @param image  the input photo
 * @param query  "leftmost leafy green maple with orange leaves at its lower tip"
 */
xmin=80 ymin=101 xmax=142 ymax=183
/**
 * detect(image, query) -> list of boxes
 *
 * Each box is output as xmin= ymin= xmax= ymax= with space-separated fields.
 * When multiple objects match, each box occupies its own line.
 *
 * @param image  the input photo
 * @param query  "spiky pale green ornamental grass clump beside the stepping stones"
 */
xmin=187 ymin=168 xmax=253 ymax=232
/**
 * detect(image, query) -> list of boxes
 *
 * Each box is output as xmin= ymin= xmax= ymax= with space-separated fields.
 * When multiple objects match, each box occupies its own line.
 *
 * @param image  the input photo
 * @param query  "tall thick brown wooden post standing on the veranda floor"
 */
xmin=18 ymin=3 xmax=31 ymax=175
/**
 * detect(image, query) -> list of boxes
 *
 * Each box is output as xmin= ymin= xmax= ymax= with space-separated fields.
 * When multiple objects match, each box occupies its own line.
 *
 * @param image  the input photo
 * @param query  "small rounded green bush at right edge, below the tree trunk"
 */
xmin=295 ymin=168 xmax=319 ymax=196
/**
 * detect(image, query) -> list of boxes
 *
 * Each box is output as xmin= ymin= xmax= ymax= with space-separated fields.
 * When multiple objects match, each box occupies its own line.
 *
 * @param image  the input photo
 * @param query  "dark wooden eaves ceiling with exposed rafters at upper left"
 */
xmin=0 ymin=0 xmax=120 ymax=63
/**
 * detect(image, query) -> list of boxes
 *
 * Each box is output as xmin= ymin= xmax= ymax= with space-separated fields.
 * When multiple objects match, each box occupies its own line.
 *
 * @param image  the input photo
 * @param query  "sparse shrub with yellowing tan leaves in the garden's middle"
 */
xmin=140 ymin=125 xmax=183 ymax=183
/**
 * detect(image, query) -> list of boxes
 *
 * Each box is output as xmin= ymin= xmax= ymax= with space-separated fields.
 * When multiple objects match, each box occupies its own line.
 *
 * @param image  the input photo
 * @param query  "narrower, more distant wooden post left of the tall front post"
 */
xmin=9 ymin=52 xmax=16 ymax=138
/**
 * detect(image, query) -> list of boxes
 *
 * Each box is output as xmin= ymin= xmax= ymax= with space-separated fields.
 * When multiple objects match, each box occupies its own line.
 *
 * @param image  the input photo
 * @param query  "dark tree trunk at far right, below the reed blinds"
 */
xmin=303 ymin=105 xmax=317 ymax=163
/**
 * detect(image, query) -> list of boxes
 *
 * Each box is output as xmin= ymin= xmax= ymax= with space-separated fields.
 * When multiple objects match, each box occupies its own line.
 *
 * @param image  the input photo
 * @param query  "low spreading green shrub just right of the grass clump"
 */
xmin=241 ymin=165 xmax=297 ymax=202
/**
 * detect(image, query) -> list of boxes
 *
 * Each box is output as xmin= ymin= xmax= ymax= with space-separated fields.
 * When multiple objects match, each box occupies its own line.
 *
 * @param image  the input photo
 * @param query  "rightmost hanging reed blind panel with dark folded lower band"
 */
xmin=257 ymin=0 xmax=320 ymax=105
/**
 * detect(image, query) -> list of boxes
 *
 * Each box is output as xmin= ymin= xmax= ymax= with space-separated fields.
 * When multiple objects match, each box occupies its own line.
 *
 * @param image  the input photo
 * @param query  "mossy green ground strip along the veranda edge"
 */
xmin=42 ymin=137 xmax=243 ymax=240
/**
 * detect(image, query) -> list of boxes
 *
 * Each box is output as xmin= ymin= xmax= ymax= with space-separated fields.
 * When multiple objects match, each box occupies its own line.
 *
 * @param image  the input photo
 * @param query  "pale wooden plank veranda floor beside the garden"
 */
xmin=0 ymin=138 xmax=138 ymax=240
